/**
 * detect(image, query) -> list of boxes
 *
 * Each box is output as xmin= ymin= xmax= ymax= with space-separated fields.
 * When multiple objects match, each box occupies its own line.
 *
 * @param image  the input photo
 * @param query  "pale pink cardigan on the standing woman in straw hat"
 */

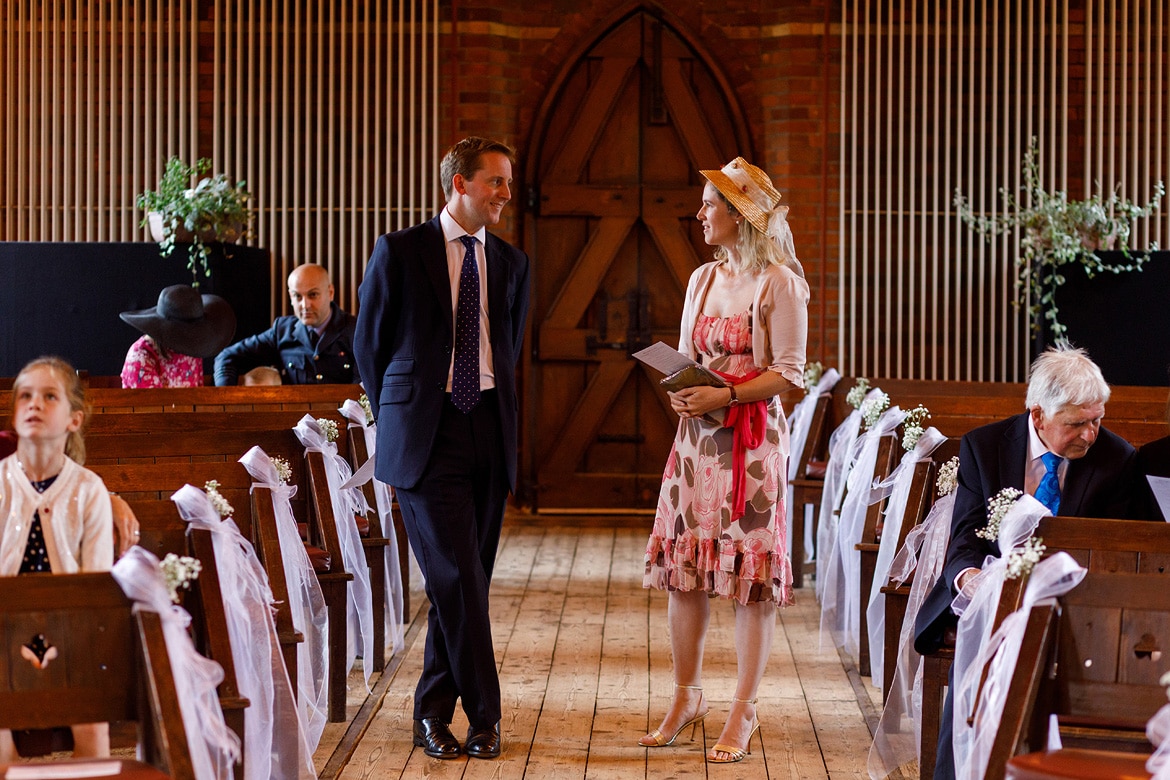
xmin=679 ymin=261 xmax=808 ymax=387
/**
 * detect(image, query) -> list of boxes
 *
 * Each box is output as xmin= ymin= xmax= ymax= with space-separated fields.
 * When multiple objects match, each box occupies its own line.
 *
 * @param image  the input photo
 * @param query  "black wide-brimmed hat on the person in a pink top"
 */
xmin=118 ymin=284 xmax=235 ymax=358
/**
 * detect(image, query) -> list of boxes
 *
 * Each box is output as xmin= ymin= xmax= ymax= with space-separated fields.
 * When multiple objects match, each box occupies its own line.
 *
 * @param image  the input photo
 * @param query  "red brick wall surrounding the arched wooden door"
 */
xmin=440 ymin=0 xmax=841 ymax=365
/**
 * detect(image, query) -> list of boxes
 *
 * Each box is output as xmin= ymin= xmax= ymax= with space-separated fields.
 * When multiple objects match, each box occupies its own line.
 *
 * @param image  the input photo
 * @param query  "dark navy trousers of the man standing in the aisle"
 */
xmin=397 ymin=391 xmax=508 ymax=727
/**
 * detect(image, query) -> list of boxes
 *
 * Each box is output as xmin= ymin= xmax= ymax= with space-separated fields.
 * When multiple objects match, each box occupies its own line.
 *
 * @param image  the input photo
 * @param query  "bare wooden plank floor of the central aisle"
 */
xmin=325 ymin=516 xmax=880 ymax=780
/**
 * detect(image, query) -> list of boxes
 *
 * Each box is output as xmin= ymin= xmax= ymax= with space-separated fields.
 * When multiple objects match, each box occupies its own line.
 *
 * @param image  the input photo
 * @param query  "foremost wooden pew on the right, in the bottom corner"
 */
xmin=986 ymin=572 xmax=1170 ymax=780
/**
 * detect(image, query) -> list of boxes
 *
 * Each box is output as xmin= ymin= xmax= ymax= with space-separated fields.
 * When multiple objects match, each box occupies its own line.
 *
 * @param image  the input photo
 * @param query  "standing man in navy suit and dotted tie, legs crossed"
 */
xmin=355 ymin=138 xmax=529 ymax=759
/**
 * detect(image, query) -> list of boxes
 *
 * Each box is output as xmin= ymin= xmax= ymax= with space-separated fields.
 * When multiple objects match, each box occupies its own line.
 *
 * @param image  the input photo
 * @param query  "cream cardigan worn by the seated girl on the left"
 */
xmin=0 ymin=455 xmax=113 ymax=577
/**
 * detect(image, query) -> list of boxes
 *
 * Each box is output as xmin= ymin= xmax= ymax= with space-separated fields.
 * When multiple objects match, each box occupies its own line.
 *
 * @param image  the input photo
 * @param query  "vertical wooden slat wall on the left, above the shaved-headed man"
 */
xmin=0 ymin=0 xmax=441 ymax=313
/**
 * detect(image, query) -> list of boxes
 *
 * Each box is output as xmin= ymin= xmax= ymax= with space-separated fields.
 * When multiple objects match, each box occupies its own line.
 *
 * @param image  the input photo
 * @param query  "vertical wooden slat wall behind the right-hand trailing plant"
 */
xmin=838 ymin=0 xmax=1170 ymax=381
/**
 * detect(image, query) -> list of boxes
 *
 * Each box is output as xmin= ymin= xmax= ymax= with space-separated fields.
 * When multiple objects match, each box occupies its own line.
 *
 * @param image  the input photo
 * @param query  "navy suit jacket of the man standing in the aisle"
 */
xmin=353 ymin=216 xmax=529 ymax=490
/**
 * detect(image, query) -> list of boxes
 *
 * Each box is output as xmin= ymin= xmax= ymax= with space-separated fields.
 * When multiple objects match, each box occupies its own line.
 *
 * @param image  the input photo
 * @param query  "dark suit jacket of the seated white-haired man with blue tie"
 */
xmin=914 ymin=413 xmax=1136 ymax=654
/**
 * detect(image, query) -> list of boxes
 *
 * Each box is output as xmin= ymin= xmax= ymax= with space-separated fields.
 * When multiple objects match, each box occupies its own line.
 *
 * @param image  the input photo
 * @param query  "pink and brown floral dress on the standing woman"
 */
xmin=645 ymin=261 xmax=807 ymax=606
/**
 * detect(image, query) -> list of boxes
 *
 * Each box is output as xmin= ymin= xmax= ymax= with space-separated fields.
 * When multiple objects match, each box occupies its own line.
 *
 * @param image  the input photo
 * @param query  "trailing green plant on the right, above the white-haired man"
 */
xmin=955 ymin=137 xmax=1165 ymax=339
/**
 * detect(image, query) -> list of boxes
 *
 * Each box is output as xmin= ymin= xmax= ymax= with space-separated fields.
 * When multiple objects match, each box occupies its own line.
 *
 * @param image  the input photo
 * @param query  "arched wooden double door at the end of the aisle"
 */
xmin=525 ymin=6 xmax=750 ymax=510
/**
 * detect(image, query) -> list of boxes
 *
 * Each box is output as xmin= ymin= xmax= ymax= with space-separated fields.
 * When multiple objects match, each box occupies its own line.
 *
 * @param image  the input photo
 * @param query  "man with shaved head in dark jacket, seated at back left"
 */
xmin=215 ymin=263 xmax=359 ymax=385
